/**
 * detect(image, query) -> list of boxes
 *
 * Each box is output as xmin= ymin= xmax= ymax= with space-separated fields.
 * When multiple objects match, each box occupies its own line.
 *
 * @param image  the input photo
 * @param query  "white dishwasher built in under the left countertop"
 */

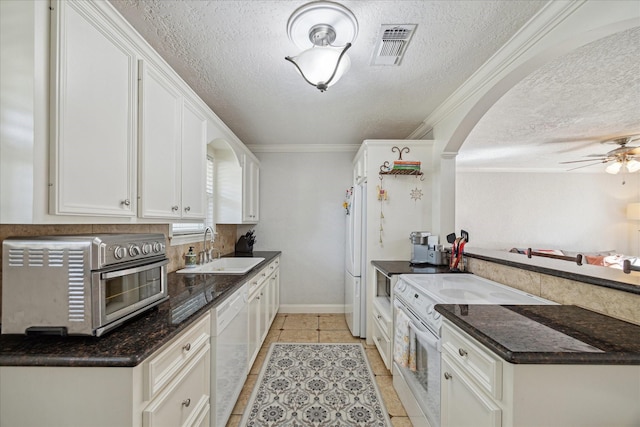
xmin=211 ymin=283 xmax=249 ymax=427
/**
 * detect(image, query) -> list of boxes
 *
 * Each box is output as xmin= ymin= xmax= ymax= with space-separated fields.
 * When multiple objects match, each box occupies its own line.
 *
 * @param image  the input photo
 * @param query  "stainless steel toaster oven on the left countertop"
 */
xmin=2 ymin=234 xmax=169 ymax=336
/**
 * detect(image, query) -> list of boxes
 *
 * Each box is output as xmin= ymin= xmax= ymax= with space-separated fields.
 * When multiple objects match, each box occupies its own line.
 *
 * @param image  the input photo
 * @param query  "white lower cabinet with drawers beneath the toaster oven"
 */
xmin=0 ymin=314 xmax=210 ymax=427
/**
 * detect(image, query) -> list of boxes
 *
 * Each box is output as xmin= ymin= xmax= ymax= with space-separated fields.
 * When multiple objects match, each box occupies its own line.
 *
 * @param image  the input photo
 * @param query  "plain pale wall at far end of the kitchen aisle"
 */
xmin=248 ymin=152 xmax=355 ymax=309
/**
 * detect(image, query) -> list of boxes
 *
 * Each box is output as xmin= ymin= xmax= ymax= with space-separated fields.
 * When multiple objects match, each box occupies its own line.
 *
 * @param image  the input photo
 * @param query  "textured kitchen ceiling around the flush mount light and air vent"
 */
xmin=111 ymin=0 xmax=546 ymax=145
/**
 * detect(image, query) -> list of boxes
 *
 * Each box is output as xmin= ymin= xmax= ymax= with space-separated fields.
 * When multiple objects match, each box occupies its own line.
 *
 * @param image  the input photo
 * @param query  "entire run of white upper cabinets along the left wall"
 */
xmin=5 ymin=0 xmax=258 ymax=224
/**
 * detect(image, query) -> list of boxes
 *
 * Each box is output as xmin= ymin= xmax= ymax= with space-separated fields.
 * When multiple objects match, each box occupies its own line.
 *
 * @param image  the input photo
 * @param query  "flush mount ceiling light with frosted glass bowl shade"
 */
xmin=285 ymin=1 xmax=358 ymax=92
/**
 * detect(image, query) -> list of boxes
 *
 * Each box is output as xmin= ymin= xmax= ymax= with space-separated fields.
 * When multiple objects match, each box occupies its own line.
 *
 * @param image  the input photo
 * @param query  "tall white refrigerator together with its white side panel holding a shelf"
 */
xmin=344 ymin=140 xmax=433 ymax=338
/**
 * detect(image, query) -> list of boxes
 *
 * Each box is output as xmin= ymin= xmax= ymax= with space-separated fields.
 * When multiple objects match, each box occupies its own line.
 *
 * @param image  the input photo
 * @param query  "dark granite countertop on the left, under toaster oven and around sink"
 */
xmin=0 ymin=251 xmax=281 ymax=367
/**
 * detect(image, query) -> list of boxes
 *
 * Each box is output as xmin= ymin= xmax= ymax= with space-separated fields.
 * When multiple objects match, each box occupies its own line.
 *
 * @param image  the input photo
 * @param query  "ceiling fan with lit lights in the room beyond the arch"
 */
xmin=560 ymin=135 xmax=640 ymax=174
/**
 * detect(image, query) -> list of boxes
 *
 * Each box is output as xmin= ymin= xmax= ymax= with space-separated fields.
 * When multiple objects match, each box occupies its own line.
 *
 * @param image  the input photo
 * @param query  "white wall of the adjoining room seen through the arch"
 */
xmin=456 ymin=172 xmax=640 ymax=255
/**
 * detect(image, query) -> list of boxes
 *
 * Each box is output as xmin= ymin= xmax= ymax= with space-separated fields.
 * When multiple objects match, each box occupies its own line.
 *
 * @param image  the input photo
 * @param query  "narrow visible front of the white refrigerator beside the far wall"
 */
xmin=344 ymin=183 xmax=367 ymax=338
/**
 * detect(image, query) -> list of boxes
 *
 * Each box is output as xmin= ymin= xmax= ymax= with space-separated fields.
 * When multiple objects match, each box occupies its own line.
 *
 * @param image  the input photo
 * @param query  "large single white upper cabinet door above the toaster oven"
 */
xmin=49 ymin=1 xmax=137 ymax=217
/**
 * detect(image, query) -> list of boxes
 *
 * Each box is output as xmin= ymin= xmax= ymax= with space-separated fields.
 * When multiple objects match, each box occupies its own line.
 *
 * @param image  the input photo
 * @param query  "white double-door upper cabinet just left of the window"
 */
xmin=139 ymin=61 xmax=206 ymax=219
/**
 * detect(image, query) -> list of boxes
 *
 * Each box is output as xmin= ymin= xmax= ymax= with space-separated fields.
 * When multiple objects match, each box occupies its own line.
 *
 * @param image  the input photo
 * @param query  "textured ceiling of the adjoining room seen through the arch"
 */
xmin=456 ymin=27 xmax=640 ymax=172
